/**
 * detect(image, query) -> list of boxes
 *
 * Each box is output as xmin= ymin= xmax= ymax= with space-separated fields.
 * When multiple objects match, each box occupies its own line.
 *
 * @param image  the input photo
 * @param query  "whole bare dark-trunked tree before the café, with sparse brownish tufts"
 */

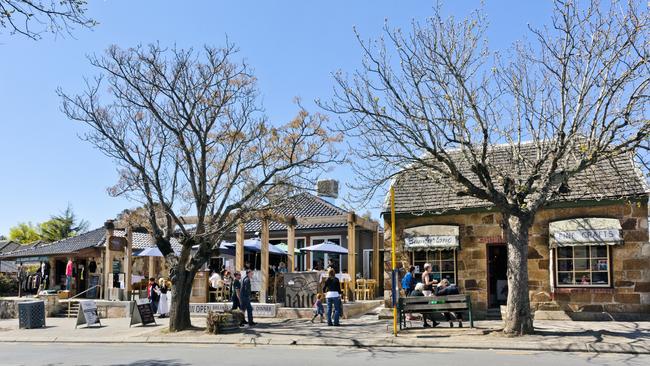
xmin=59 ymin=44 xmax=338 ymax=331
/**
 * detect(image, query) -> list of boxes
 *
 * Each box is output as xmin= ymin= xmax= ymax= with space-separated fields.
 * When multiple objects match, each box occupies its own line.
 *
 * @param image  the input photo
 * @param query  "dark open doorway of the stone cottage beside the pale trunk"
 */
xmin=487 ymin=244 xmax=508 ymax=308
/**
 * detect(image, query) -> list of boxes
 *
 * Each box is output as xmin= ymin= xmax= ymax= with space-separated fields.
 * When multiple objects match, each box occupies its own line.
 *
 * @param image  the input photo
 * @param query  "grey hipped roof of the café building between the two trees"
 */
xmin=244 ymin=192 xmax=347 ymax=232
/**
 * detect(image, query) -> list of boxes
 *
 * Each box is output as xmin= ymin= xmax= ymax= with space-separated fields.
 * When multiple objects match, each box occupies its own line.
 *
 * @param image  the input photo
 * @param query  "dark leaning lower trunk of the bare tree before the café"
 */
xmin=169 ymin=264 xmax=195 ymax=332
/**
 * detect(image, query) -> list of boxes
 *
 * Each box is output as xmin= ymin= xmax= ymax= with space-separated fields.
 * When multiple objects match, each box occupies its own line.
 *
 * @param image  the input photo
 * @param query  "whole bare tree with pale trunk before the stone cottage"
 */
xmin=322 ymin=0 xmax=650 ymax=334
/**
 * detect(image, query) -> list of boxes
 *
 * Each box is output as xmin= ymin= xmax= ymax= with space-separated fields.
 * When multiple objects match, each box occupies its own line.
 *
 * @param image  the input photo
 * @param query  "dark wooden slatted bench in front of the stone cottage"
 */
xmin=397 ymin=294 xmax=474 ymax=329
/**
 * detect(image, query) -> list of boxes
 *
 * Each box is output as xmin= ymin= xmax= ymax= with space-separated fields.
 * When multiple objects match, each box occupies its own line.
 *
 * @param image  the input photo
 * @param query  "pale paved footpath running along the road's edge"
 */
xmin=0 ymin=315 xmax=650 ymax=354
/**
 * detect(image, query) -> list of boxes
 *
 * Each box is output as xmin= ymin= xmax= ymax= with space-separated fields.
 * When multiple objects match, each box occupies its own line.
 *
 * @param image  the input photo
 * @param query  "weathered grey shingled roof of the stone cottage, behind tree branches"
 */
xmin=384 ymin=144 xmax=648 ymax=215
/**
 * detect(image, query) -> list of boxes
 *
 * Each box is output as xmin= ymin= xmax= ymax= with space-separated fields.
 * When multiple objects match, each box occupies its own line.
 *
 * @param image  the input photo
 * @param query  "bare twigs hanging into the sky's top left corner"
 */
xmin=0 ymin=0 xmax=97 ymax=40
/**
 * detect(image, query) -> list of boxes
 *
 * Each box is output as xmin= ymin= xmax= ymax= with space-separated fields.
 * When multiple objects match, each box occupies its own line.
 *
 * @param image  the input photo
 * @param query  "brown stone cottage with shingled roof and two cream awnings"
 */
xmin=383 ymin=149 xmax=650 ymax=318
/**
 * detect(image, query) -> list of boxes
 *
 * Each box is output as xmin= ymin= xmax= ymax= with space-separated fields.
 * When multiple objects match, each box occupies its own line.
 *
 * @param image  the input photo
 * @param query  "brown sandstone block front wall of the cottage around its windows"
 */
xmin=384 ymin=201 xmax=650 ymax=316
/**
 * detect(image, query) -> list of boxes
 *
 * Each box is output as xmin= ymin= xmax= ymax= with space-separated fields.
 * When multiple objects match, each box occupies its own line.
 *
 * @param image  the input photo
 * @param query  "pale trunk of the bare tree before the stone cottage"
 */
xmin=503 ymin=214 xmax=534 ymax=335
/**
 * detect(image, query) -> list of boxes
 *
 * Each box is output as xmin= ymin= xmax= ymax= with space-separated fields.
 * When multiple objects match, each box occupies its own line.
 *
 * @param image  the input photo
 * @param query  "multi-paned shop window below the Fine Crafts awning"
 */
xmin=556 ymin=245 xmax=611 ymax=287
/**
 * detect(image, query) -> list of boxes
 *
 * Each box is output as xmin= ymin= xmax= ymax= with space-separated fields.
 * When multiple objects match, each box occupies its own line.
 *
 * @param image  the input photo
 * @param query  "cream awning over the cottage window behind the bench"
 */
xmin=404 ymin=225 xmax=459 ymax=250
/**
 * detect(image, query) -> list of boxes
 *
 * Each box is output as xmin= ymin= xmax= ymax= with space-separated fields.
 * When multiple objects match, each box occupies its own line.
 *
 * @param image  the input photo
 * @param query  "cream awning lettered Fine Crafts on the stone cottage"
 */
xmin=548 ymin=217 xmax=623 ymax=248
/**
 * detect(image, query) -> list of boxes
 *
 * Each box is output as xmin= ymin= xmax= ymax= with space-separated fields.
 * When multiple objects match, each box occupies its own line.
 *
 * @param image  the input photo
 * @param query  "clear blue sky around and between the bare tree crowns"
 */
xmin=0 ymin=0 xmax=552 ymax=235
